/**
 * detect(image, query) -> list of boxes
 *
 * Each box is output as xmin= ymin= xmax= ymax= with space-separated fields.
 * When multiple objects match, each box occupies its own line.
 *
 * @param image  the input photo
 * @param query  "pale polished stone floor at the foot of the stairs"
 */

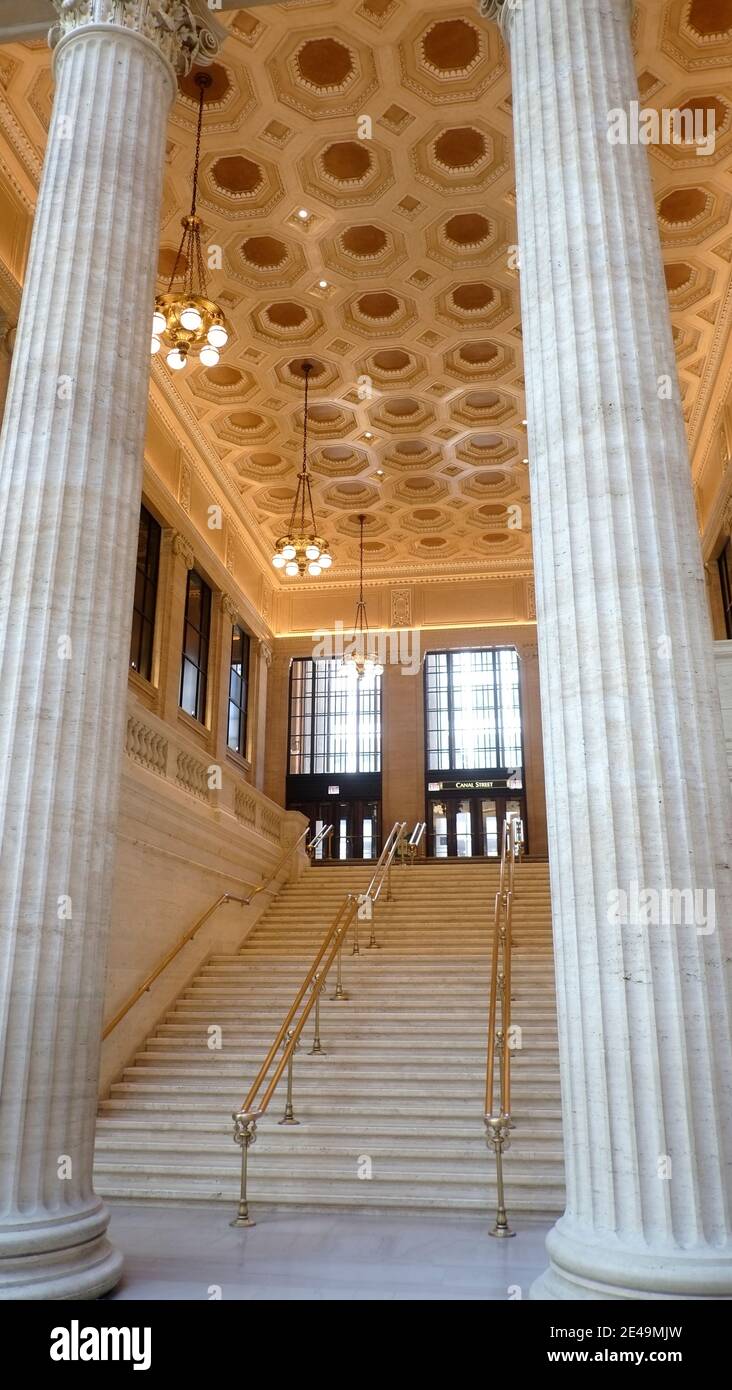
xmin=101 ymin=1202 xmax=549 ymax=1301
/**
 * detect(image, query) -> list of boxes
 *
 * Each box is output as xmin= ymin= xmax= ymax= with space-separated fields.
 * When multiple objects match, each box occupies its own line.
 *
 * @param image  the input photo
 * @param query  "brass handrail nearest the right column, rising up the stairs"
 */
xmin=485 ymin=816 xmax=524 ymax=1237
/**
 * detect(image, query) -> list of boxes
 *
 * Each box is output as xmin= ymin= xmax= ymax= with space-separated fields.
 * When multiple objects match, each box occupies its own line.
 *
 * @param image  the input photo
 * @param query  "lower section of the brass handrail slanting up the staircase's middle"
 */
xmin=231 ymin=892 xmax=358 ymax=1226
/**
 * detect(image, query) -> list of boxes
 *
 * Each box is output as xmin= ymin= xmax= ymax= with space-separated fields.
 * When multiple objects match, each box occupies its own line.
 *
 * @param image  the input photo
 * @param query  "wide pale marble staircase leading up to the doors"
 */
xmin=96 ymin=860 xmax=563 ymax=1215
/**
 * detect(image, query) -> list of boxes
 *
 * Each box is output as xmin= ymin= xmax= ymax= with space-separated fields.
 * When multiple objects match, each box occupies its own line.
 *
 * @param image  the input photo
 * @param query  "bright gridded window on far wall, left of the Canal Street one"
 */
xmin=289 ymin=657 xmax=381 ymax=774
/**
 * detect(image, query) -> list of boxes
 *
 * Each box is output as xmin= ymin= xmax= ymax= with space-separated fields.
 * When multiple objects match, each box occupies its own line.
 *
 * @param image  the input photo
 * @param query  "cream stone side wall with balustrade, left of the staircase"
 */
xmin=100 ymin=694 xmax=307 ymax=1094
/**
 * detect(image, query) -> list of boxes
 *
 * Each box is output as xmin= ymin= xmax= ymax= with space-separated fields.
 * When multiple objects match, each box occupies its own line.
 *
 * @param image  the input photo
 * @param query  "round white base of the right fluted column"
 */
xmin=529 ymin=1222 xmax=732 ymax=1302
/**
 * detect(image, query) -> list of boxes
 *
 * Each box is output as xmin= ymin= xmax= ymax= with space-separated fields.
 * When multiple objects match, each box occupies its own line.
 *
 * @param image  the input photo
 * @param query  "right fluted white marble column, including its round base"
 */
xmin=483 ymin=0 xmax=732 ymax=1300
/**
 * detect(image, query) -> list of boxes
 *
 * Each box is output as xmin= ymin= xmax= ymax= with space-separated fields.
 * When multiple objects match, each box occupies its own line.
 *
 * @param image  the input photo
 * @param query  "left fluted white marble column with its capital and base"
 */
xmin=0 ymin=0 xmax=220 ymax=1298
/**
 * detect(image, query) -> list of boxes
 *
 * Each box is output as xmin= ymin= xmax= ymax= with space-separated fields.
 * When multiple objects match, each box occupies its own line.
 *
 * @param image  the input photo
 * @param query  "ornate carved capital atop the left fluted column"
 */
xmin=49 ymin=0 xmax=226 ymax=72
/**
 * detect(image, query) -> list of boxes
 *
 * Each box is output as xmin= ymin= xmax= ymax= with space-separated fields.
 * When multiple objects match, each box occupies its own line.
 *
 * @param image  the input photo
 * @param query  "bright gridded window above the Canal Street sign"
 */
xmin=425 ymin=646 xmax=524 ymax=771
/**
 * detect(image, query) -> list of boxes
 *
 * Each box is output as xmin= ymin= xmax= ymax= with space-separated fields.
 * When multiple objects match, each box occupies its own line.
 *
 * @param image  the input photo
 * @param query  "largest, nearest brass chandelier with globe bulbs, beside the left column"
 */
xmin=150 ymin=72 xmax=229 ymax=371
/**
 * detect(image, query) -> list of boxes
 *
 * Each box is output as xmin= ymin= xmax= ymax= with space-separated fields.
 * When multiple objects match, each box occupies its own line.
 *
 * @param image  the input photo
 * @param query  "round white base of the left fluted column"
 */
xmin=0 ymin=1204 xmax=122 ymax=1302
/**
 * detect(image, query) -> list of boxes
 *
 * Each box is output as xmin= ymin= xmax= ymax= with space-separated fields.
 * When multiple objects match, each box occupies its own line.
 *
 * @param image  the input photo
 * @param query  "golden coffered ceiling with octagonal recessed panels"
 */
xmin=0 ymin=0 xmax=732 ymax=603
